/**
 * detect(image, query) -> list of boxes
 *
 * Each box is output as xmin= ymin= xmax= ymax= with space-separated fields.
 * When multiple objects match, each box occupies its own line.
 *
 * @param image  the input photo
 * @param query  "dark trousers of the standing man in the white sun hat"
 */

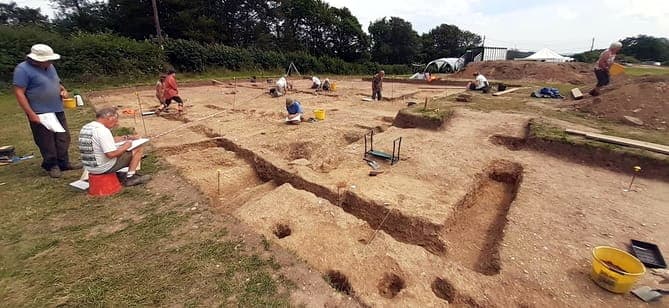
xmin=30 ymin=112 xmax=70 ymax=171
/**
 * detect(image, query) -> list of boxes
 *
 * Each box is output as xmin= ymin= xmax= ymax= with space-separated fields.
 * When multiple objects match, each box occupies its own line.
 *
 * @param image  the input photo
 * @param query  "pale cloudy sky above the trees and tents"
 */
xmin=10 ymin=0 xmax=669 ymax=56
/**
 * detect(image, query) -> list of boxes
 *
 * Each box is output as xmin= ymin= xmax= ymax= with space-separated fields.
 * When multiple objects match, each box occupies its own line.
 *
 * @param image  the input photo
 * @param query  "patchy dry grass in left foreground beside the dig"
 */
xmin=0 ymin=92 xmax=293 ymax=307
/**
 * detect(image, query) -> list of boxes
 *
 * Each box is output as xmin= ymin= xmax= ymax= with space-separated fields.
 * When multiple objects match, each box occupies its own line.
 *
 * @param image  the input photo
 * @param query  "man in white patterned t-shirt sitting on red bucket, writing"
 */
xmin=79 ymin=107 xmax=151 ymax=186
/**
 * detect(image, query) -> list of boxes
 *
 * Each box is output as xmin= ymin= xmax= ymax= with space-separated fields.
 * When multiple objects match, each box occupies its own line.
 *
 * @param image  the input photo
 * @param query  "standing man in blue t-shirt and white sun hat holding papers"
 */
xmin=14 ymin=44 xmax=81 ymax=178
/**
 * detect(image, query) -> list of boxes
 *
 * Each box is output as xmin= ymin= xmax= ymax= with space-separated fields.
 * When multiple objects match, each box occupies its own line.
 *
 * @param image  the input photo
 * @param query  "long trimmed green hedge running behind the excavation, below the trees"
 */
xmin=0 ymin=26 xmax=411 ymax=83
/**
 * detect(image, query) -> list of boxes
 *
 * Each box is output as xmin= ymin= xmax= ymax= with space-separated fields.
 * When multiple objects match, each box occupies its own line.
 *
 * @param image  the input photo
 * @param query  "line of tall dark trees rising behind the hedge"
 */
xmin=0 ymin=0 xmax=481 ymax=64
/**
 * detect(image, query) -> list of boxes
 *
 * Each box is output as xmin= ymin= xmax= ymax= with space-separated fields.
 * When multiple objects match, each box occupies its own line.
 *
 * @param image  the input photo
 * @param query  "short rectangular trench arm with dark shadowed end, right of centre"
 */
xmin=443 ymin=160 xmax=523 ymax=275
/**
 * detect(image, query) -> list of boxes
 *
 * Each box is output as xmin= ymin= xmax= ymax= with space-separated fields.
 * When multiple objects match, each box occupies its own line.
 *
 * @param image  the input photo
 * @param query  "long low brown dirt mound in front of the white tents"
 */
xmin=454 ymin=61 xmax=595 ymax=85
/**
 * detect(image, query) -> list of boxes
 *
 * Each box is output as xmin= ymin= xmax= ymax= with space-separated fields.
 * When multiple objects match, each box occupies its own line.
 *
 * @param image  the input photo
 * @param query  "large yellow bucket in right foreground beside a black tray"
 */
xmin=590 ymin=246 xmax=646 ymax=293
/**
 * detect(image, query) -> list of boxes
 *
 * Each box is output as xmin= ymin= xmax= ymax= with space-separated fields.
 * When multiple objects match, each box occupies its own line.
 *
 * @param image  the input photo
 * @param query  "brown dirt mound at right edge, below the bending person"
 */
xmin=577 ymin=76 xmax=669 ymax=129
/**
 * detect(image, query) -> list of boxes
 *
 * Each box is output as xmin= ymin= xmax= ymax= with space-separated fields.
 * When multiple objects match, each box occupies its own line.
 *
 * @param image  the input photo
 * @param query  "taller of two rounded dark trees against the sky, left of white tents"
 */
xmin=368 ymin=17 xmax=421 ymax=64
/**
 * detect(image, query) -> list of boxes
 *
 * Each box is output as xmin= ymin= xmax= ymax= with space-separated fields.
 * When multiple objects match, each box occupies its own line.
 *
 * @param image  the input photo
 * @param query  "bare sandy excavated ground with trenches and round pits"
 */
xmin=90 ymin=80 xmax=669 ymax=307
